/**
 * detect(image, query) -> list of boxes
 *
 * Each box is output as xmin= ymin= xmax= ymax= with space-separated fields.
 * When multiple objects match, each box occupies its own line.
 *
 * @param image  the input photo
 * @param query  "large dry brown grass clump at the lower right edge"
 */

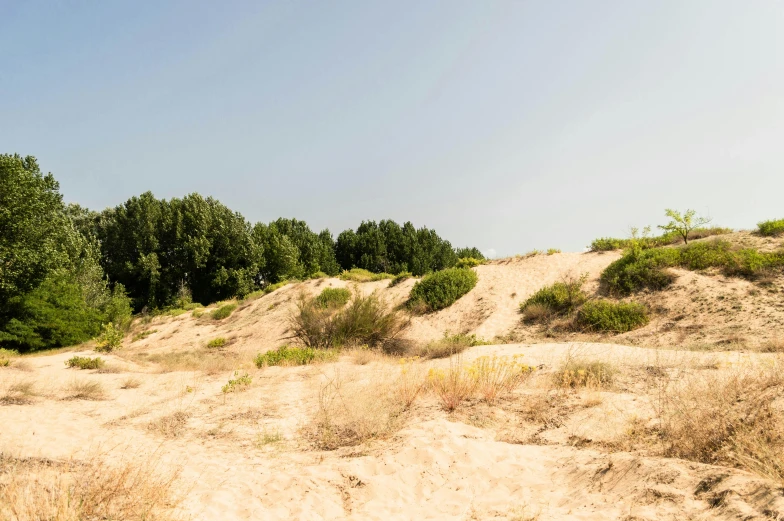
xmin=654 ymin=368 xmax=784 ymax=482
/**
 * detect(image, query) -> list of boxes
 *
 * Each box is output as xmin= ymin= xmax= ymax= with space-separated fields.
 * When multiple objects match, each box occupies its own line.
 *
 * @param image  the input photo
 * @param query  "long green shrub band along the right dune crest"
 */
xmin=601 ymin=239 xmax=784 ymax=295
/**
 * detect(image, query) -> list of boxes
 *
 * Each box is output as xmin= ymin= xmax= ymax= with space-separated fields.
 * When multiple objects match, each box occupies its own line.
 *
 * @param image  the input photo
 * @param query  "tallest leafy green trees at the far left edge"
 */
xmin=0 ymin=155 xmax=130 ymax=351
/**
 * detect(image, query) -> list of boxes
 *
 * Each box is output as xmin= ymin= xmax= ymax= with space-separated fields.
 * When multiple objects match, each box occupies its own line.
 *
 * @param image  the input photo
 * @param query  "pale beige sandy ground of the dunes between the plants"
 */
xmin=0 ymin=238 xmax=784 ymax=521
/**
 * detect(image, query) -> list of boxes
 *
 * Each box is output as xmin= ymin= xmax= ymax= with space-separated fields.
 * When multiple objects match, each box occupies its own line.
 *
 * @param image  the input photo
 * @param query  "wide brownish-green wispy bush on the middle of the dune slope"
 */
xmin=290 ymin=292 xmax=403 ymax=348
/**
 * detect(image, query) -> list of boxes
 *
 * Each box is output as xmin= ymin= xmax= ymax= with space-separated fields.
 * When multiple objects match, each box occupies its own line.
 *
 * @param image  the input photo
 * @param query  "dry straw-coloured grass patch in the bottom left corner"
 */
xmin=0 ymin=454 xmax=180 ymax=521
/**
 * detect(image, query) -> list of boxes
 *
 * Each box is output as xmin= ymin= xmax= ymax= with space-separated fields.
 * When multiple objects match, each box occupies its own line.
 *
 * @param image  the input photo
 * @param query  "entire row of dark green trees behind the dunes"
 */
xmin=0 ymin=155 xmax=483 ymax=350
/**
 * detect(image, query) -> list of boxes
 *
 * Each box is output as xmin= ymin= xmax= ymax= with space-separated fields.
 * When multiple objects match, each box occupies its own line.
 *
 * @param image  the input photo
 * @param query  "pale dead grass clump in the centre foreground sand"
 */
xmin=310 ymin=371 xmax=403 ymax=450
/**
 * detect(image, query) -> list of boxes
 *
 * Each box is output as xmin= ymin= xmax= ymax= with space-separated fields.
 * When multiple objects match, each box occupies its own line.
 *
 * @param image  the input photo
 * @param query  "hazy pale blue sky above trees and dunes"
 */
xmin=0 ymin=0 xmax=784 ymax=256
